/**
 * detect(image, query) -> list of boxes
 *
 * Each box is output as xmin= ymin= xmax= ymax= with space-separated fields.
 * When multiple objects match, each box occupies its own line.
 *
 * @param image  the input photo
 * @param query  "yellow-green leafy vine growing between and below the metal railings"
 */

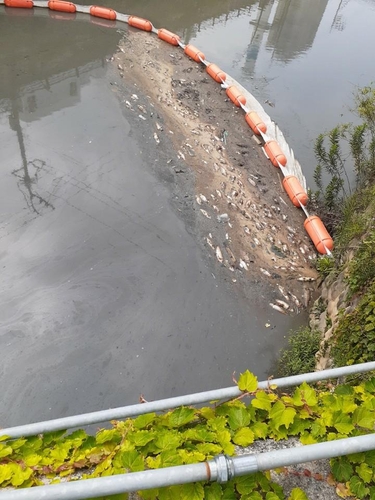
xmin=0 ymin=371 xmax=375 ymax=500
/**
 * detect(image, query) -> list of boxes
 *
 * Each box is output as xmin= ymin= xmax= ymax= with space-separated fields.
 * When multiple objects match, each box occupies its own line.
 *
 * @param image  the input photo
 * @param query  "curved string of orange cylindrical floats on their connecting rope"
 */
xmin=0 ymin=0 xmax=334 ymax=255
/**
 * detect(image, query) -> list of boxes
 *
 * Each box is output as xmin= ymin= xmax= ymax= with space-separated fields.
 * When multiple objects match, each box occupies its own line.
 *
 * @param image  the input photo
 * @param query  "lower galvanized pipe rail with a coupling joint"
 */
xmin=0 ymin=434 xmax=375 ymax=500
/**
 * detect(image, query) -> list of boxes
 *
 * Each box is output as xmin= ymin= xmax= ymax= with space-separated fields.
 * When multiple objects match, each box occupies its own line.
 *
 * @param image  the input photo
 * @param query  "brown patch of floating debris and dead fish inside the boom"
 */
xmin=113 ymin=33 xmax=316 ymax=313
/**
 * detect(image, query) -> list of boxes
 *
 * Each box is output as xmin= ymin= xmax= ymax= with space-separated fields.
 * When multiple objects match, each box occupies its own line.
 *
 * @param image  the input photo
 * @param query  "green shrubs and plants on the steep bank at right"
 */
xmin=281 ymin=86 xmax=375 ymax=374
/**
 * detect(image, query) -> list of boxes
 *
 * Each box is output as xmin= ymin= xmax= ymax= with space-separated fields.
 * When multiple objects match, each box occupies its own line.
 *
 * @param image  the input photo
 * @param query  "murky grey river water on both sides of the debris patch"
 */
xmin=0 ymin=0 xmax=375 ymax=427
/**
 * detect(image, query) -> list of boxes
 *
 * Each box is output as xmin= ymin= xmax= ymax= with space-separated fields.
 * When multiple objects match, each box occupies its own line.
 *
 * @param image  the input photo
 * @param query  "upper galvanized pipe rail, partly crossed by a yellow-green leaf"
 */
xmin=0 ymin=361 xmax=375 ymax=438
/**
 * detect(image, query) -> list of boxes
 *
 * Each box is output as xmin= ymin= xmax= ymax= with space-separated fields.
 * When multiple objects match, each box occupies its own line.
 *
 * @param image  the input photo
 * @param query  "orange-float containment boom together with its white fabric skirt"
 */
xmin=0 ymin=0 xmax=333 ymax=254
